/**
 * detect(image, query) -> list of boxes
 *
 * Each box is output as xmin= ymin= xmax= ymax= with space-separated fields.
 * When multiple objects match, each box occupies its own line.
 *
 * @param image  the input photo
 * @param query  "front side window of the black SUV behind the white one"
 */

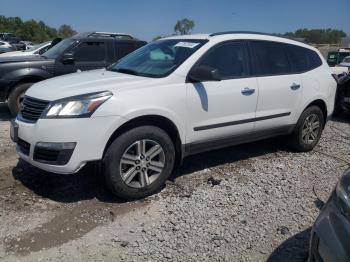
xmin=74 ymin=42 xmax=106 ymax=62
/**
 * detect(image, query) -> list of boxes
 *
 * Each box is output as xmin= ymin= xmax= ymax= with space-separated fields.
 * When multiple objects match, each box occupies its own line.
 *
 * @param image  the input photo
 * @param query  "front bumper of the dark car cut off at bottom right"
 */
xmin=309 ymin=192 xmax=350 ymax=262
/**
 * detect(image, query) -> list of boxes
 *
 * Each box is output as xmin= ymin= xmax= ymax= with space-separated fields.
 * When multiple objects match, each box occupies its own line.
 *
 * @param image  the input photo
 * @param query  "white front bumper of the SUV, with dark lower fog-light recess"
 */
xmin=16 ymin=116 xmax=125 ymax=174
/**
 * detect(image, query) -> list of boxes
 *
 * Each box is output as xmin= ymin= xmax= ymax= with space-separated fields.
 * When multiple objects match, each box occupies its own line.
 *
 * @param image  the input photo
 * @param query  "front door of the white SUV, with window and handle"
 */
xmin=187 ymin=41 xmax=259 ymax=143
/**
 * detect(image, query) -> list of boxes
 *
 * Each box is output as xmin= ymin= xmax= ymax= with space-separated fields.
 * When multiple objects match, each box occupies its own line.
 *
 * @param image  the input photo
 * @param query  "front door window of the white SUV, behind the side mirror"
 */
xmin=198 ymin=41 xmax=249 ymax=79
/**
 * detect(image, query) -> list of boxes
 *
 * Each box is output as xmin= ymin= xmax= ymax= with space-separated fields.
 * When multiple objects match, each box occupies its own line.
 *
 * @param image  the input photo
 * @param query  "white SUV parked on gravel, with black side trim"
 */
xmin=12 ymin=32 xmax=336 ymax=199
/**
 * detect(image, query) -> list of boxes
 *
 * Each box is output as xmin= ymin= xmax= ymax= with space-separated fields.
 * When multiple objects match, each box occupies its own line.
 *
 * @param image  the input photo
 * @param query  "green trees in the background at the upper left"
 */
xmin=0 ymin=16 xmax=76 ymax=43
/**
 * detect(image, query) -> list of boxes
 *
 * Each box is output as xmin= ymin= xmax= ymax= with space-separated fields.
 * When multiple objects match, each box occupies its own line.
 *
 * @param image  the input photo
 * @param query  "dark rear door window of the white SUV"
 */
xmin=252 ymin=41 xmax=291 ymax=75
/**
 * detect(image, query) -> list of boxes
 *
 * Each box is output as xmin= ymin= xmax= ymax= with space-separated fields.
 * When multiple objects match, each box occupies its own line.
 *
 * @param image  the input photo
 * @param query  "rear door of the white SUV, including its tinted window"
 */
xmin=250 ymin=41 xmax=303 ymax=131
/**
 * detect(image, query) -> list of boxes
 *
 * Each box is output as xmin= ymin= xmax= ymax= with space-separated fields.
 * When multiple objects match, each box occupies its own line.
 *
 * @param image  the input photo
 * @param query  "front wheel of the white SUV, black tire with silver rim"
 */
xmin=103 ymin=126 xmax=175 ymax=200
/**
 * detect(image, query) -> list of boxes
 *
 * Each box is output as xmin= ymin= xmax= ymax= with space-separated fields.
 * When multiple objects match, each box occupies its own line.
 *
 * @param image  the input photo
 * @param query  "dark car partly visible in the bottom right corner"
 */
xmin=309 ymin=169 xmax=350 ymax=262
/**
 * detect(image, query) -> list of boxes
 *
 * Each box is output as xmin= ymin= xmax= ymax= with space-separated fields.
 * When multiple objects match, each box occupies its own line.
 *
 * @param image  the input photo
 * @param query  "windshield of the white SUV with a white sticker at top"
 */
xmin=108 ymin=39 xmax=207 ymax=78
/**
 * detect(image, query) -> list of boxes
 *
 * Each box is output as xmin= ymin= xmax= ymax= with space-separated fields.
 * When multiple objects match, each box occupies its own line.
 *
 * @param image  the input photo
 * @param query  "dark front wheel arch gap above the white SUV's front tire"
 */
xmin=103 ymin=114 xmax=184 ymax=164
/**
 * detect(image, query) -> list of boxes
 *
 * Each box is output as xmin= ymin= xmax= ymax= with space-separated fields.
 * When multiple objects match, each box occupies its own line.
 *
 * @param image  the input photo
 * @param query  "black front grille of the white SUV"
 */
xmin=19 ymin=96 xmax=49 ymax=123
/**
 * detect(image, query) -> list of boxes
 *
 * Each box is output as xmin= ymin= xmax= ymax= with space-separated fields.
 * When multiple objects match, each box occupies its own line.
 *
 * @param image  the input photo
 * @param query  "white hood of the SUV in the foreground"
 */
xmin=26 ymin=69 xmax=156 ymax=101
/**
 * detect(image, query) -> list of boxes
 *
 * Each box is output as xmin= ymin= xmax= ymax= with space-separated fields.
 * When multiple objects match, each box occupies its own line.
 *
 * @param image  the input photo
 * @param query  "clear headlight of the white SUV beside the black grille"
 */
xmin=42 ymin=91 xmax=113 ymax=118
